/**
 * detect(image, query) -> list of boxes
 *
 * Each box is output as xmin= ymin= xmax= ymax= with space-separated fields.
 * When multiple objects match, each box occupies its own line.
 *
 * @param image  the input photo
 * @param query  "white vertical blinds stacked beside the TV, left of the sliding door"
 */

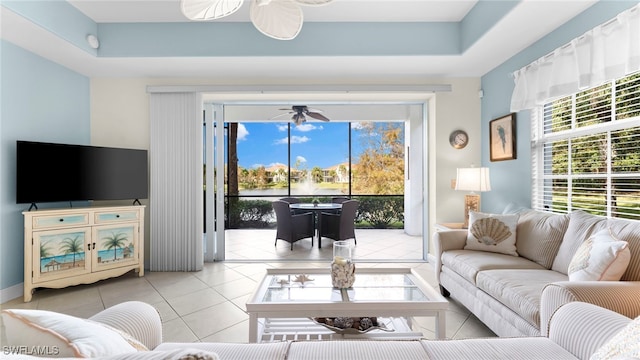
xmin=149 ymin=93 xmax=203 ymax=271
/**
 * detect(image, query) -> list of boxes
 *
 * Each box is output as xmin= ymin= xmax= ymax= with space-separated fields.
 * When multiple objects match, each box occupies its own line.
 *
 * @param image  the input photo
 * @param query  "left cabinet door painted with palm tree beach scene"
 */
xmin=33 ymin=227 xmax=91 ymax=283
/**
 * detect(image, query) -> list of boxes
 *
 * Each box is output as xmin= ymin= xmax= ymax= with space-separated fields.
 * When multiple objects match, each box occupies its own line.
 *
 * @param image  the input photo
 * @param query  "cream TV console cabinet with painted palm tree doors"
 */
xmin=22 ymin=205 xmax=144 ymax=302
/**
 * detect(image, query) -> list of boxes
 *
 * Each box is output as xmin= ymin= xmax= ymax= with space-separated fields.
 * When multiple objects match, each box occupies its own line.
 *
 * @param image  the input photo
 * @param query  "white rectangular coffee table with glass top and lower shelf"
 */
xmin=246 ymin=265 xmax=449 ymax=342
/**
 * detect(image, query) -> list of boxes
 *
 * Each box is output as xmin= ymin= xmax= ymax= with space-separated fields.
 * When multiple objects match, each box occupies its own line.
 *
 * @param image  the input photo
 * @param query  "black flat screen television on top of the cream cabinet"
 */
xmin=16 ymin=141 xmax=148 ymax=204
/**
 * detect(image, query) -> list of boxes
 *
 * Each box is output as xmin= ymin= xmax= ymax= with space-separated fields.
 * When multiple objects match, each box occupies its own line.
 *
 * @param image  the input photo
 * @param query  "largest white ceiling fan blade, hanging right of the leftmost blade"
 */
xmin=249 ymin=0 xmax=303 ymax=40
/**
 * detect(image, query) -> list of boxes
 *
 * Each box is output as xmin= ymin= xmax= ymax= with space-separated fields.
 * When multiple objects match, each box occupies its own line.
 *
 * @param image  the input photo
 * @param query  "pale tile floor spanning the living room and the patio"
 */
xmin=1 ymin=232 xmax=495 ymax=342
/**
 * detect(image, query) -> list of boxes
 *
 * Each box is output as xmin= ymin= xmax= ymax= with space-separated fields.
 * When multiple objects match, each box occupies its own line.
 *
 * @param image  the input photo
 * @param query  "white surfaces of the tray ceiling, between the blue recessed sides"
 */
xmin=0 ymin=0 xmax=596 ymax=79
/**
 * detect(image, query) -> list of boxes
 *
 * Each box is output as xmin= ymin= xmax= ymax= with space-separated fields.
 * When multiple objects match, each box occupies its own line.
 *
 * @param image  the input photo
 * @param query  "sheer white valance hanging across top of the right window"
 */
xmin=511 ymin=5 xmax=640 ymax=112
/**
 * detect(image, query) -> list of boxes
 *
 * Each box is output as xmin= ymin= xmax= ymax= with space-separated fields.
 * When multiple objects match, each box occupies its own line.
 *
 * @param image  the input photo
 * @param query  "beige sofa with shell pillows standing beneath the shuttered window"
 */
xmin=433 ymin=210 xmax=640 ymax=336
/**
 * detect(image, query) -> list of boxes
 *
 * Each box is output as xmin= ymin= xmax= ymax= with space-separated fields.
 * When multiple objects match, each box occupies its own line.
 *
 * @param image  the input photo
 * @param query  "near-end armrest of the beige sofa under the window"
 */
xmin=540 ymin=281 xmax=640 ymax=336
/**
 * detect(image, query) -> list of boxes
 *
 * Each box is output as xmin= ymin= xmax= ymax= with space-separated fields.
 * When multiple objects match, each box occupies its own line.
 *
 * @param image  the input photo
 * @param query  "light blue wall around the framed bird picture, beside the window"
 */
xmin=481 ymin=0 xmax=638 ymax=212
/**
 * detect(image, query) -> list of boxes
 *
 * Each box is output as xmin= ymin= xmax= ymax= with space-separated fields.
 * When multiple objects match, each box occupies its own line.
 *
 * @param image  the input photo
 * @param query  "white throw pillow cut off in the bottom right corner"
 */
xmin=590 ymin=316 xmax=640 ymax=360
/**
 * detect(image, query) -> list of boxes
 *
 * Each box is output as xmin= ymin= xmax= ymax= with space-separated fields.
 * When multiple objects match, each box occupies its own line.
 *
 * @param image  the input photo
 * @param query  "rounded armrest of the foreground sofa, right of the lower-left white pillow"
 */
xmin=89 ymin=301 xmax=162 ymax=350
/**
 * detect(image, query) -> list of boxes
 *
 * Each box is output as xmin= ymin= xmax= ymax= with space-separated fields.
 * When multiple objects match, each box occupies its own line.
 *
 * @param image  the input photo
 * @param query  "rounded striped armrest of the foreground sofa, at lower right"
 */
xmin=549 ymin=302 xmax=631 ymax=359
